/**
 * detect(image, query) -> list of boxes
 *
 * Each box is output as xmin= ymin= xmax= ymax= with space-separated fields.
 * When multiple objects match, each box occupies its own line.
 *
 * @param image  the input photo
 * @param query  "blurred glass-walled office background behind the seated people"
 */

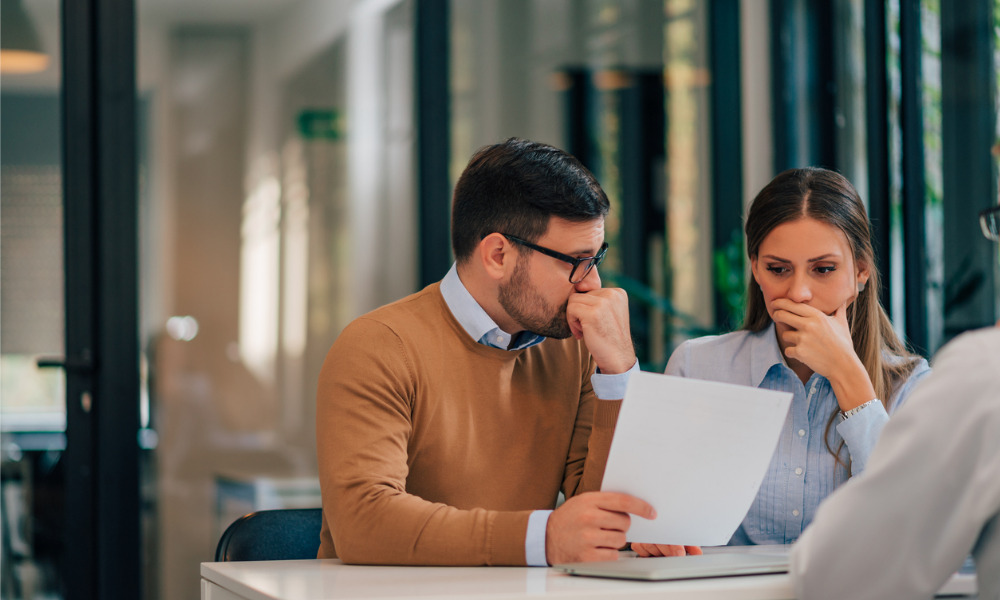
xmin=0 ymin=0 xmax=1000 ymax=600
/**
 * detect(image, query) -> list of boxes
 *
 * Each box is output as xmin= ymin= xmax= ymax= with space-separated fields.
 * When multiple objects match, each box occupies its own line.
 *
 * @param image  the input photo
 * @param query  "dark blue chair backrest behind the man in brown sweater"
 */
xmin=215 ymin=508 xmax=323 ymax=562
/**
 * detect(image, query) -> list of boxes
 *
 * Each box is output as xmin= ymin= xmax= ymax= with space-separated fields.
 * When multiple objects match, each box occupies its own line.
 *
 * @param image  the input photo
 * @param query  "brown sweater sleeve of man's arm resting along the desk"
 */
xmin=316 ymin=318 xmax=531 ymax=565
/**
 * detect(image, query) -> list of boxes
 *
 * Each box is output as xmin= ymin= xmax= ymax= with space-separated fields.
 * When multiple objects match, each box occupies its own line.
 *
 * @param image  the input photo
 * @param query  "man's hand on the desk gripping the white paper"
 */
xmin=545 ymin=492 xmax=656 ymax=565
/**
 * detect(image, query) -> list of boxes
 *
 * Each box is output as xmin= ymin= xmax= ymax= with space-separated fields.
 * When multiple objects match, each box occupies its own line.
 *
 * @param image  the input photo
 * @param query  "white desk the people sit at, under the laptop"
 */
xmin=201 ymin=560 xmax=794 ymax=600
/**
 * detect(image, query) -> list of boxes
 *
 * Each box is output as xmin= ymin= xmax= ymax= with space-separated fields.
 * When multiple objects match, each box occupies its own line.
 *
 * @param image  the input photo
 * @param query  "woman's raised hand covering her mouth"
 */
xmin=772 ymin=298 xmax=875 ymax=411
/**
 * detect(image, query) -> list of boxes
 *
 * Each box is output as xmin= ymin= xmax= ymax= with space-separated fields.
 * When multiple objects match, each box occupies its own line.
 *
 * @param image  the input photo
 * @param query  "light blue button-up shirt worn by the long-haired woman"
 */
xmin=666 ymin=323 xmax=930 ymax=545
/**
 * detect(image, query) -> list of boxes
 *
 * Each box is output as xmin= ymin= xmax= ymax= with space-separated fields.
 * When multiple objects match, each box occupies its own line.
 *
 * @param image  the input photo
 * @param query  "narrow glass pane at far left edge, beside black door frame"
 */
xmin=0 ymin=0 xmax=66 ymax=599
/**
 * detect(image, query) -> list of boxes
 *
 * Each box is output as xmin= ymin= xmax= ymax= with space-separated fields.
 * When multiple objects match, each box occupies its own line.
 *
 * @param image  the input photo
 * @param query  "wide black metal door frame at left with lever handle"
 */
xmin=62 ymin=0 xmax=141 ymax=600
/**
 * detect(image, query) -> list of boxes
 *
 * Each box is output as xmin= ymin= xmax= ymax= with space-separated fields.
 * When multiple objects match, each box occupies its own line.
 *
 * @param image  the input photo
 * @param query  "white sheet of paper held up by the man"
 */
xmin=601 ymin=372 xmax=792 ymax=546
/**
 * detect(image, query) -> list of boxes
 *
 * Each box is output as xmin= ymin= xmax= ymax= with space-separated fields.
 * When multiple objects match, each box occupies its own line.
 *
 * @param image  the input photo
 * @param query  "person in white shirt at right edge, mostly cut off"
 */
xmin=791 ymin=206 xmax=1000 ymax=600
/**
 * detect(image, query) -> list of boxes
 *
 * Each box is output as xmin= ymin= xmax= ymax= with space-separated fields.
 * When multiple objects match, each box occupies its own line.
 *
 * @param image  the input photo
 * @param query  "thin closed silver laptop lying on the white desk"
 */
xmin=553 ymin=552 xmax=788 ymax=581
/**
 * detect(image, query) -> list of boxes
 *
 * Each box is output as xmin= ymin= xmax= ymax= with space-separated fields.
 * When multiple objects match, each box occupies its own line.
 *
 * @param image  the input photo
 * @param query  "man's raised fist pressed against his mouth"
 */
xmin=566 ymin=288 xmax=636 ymax=375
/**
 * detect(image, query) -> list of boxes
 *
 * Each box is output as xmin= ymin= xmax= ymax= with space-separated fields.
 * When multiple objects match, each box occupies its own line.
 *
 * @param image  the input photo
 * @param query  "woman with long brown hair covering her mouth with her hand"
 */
xmin=633 ymin=168 xmax=929 ymax=555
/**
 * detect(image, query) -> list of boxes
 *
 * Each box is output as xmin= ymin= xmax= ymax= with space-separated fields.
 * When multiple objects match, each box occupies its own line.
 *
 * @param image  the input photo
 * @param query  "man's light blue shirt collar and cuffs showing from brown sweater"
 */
xmin=441 ymin=264 xmax=639 ymax=567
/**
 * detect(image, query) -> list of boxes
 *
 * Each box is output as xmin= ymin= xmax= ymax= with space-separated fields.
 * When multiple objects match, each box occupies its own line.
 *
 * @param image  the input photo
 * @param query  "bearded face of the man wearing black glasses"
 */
xmin=497 ymin=217 xmax=604 ymax=339
